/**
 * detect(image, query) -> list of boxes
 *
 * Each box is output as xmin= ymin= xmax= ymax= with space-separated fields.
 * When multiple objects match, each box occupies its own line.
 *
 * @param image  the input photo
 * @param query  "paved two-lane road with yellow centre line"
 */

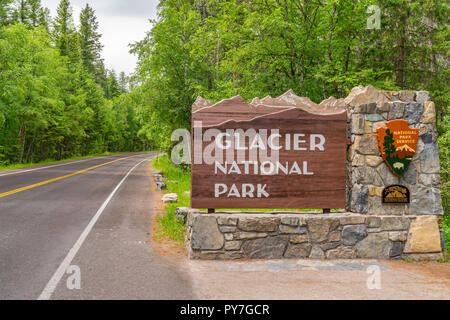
xmin=0 ymin=153 xmax=197 ymax=300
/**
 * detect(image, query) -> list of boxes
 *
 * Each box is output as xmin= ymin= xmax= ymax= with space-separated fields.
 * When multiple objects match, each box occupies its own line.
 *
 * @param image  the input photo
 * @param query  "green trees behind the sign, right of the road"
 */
xmin=131 ymin=0 xmax=450 ymax=150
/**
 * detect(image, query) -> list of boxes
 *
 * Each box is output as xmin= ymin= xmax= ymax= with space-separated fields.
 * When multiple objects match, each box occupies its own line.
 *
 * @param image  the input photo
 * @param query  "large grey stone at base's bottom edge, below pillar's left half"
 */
xmin=356 ymin=232 xmax=391 ymax=260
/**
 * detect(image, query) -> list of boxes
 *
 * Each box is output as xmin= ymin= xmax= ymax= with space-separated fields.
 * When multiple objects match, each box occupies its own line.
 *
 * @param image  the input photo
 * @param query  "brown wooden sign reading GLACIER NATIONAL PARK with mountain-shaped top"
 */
xmin=191 ymin=91 xmax=347 ymax=209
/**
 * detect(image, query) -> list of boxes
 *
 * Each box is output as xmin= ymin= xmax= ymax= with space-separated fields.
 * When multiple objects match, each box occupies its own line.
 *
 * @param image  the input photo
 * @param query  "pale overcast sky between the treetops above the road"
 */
xmin=42 ymin=0 xmax=159 ymax=74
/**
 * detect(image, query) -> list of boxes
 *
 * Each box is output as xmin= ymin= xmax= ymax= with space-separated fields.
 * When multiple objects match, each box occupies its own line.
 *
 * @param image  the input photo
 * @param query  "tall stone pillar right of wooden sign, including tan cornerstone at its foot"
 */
xmin=345 ymin=86 xmax=445 ymax=255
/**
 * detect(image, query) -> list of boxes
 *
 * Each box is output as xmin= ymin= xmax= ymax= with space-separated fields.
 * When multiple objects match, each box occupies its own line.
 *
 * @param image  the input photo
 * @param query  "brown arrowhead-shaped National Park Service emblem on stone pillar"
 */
xmin=377 ymin=120 xmax=419 ymax=177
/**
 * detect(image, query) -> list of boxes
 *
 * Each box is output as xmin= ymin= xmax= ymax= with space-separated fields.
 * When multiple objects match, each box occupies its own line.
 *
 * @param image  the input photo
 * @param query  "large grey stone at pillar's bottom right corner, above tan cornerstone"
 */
xmin=410 ymin=184 xmax=444 ymax=215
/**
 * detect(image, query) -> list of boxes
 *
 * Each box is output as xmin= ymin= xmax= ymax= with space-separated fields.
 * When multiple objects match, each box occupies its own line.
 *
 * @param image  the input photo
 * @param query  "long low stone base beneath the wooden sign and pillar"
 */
xmin=187 ymin=210 xmax=445 ymax=261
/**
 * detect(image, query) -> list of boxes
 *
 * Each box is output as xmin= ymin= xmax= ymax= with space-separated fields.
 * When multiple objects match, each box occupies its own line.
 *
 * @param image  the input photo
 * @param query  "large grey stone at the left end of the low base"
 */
xmin=191 ymin=216 xmax=225 ymax=250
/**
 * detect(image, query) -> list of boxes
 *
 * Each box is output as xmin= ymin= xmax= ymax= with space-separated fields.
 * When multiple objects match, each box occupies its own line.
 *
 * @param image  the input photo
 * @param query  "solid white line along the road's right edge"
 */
xmin=37 ymin=158 xmax=152 ymax=300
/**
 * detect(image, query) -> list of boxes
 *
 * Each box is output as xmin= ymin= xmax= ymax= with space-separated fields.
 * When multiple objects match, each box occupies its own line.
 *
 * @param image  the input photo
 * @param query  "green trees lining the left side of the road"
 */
xmin=0 ymin=0 xmax=148 ymax=166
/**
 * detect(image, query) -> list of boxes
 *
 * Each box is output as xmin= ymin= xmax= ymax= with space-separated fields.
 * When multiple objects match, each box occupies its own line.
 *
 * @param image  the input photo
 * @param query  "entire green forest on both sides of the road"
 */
xmin=0 ymin=0 xmax=450 ymax=168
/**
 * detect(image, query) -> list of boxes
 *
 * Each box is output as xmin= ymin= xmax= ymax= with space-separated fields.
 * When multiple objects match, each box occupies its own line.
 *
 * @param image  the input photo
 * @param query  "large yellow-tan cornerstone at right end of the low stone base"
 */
xmin=405 ymin=216 xmax=442 ymax=253
